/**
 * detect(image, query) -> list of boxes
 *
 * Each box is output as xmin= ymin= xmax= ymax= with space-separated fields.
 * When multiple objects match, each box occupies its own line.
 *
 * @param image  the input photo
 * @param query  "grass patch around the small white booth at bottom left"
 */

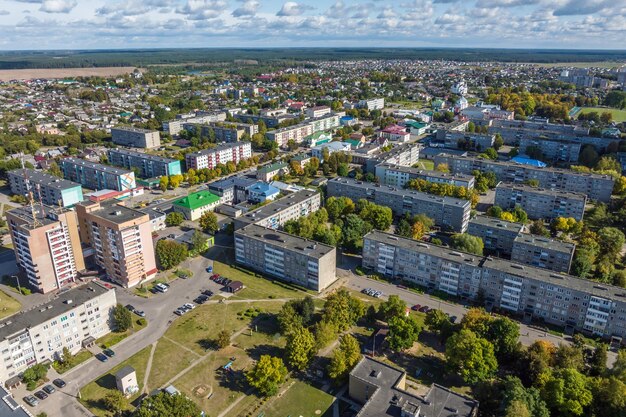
xmin=80 ymin=346 xmax=152 ymax=417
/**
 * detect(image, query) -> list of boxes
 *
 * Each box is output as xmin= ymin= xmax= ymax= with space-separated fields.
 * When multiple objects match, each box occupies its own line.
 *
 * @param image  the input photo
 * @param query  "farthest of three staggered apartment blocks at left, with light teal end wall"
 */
xmin=107 ymin=148 xmax=182 ymax=178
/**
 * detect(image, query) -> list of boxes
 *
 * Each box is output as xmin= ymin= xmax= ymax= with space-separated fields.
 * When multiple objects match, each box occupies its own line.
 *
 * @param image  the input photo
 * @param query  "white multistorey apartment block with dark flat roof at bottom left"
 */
xmin=0 ymin=281 xmax=117 ymax=383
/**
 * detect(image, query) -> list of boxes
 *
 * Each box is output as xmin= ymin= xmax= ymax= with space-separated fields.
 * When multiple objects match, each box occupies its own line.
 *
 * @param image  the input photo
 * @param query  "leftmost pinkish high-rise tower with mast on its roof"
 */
xmin=6 ymin=203 xmax=85 ymax=294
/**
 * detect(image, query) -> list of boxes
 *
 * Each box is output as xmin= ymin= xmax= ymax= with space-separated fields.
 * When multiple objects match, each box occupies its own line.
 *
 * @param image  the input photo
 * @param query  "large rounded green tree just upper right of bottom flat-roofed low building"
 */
xmin=446 ymin=329 xmax=498 ymax=384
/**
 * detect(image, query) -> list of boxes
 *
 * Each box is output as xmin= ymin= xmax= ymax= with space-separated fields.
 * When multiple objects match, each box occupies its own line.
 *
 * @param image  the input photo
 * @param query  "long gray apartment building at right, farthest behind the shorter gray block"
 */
xmin=434 ymin=154 xmax=615 ymax=202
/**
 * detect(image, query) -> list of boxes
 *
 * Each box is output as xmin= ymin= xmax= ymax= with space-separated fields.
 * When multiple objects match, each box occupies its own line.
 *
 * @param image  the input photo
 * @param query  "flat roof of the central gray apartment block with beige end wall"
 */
xmin=235 ymin=224 xmax=335 ymax=259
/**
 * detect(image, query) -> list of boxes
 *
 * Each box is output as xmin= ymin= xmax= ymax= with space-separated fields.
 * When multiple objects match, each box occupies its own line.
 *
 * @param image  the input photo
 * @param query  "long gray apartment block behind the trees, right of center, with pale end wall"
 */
xmin=326 ymin=178 xmax=471 ymax=233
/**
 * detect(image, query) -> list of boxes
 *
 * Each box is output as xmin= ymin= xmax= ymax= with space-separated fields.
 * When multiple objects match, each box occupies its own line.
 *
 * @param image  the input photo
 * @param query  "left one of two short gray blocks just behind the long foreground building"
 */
xmin=467 ymin=216 xmax=525 ymax=256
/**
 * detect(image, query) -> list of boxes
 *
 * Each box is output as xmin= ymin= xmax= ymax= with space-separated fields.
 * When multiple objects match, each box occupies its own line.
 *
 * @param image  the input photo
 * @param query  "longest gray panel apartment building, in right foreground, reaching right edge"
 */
xmin=363 ymin=231 xmax=626 ymax=339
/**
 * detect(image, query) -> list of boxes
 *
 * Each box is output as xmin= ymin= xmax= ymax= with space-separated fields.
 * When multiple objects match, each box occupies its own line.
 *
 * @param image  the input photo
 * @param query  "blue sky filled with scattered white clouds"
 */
xmin=0 ymin=0 xmax=626 ymax=50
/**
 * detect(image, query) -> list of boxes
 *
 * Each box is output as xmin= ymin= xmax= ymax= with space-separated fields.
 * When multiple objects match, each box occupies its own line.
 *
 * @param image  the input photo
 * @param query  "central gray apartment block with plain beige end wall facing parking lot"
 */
xmin=235 ymin=224 xmax=337 ymax=292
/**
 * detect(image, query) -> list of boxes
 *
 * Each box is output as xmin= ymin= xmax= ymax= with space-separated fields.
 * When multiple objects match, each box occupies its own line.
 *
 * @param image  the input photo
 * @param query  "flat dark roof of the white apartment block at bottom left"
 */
xmin=0 ymin=281 xmax=112 ymax=339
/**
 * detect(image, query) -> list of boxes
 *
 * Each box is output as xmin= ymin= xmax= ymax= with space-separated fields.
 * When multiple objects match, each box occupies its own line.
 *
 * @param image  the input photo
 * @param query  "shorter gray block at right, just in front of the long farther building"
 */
xmin=495 ymin=182 xmax=587 ymax=220
